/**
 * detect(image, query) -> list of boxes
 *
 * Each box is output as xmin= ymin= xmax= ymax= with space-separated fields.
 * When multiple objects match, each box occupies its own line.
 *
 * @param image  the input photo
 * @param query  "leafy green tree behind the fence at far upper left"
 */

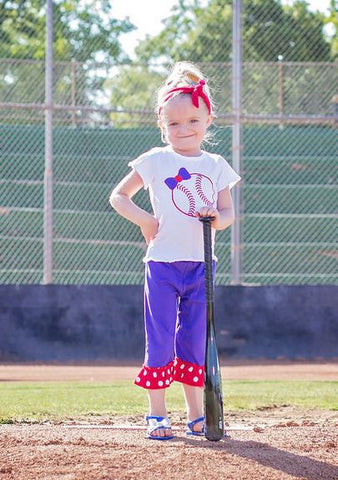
xmin=0 ymin=0 xmax=135 ymax=121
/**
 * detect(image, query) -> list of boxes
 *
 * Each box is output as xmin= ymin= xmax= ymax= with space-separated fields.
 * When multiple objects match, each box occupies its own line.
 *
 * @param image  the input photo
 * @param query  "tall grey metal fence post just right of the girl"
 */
xmin=231 ymin=0 xmax=242 ymax=285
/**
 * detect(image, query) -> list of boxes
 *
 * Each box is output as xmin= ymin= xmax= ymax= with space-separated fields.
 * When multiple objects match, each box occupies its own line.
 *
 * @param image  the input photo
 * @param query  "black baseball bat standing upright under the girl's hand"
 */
xmin=200 ymin=217 xmax=224 ymax=441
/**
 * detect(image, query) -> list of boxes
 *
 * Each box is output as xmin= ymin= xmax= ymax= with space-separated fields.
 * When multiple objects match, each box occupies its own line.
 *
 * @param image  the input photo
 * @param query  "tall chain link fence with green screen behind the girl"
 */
xmin=0 ymin=0 xmax=338 ymax=285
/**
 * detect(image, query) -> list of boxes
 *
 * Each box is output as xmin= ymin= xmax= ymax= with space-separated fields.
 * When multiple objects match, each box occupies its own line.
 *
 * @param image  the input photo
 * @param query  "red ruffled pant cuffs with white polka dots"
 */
xmin=134 ymin=358 xmax=204 ymax=390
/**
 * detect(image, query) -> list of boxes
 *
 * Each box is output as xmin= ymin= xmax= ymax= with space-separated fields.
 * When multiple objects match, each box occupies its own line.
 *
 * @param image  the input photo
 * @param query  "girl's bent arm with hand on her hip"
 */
xmin=109 ymin=170 xmax=158 ymax=244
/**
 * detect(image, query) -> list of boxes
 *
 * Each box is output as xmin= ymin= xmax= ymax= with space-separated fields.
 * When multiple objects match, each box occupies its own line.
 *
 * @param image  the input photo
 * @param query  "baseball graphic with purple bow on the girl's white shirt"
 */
xmin=164 ymin=168 xmax=216 ymax=217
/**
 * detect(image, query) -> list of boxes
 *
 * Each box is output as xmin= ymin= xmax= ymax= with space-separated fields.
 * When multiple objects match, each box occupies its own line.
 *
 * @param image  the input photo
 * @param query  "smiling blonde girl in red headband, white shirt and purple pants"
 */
xmin=110 ymin=62 xmax=240 ymax=440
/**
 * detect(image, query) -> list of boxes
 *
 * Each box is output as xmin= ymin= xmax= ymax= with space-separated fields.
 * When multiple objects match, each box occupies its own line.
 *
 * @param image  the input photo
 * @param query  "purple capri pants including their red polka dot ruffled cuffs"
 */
xmin=135 ymin=261 xmax=215 ymax=389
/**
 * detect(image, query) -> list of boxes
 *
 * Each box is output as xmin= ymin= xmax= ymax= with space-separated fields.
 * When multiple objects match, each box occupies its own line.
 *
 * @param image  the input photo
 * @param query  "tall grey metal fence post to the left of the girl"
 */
xmin=43 ymin=0 xmax=53 ymax=284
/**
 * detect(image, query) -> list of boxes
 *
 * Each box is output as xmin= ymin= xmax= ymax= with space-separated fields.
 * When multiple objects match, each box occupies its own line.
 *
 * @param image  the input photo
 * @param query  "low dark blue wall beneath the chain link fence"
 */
xmin=0 ymin=285 xmax=338 ymax=362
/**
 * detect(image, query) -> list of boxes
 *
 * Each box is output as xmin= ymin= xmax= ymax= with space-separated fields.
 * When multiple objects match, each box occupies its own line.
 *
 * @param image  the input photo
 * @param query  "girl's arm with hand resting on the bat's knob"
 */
xmin=197 ymin=187 xmax=235 ymax=230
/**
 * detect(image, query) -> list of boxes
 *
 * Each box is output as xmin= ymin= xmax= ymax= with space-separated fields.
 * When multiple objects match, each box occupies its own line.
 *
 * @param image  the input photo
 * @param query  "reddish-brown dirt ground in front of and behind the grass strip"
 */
xmin=0 ymin=361 xmax=338 ymax=480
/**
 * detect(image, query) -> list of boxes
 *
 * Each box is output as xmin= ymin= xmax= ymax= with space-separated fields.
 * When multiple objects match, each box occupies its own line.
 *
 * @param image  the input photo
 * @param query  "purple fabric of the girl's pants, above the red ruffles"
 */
xmin=144 ymin=261 xmax=206 ymax=367
